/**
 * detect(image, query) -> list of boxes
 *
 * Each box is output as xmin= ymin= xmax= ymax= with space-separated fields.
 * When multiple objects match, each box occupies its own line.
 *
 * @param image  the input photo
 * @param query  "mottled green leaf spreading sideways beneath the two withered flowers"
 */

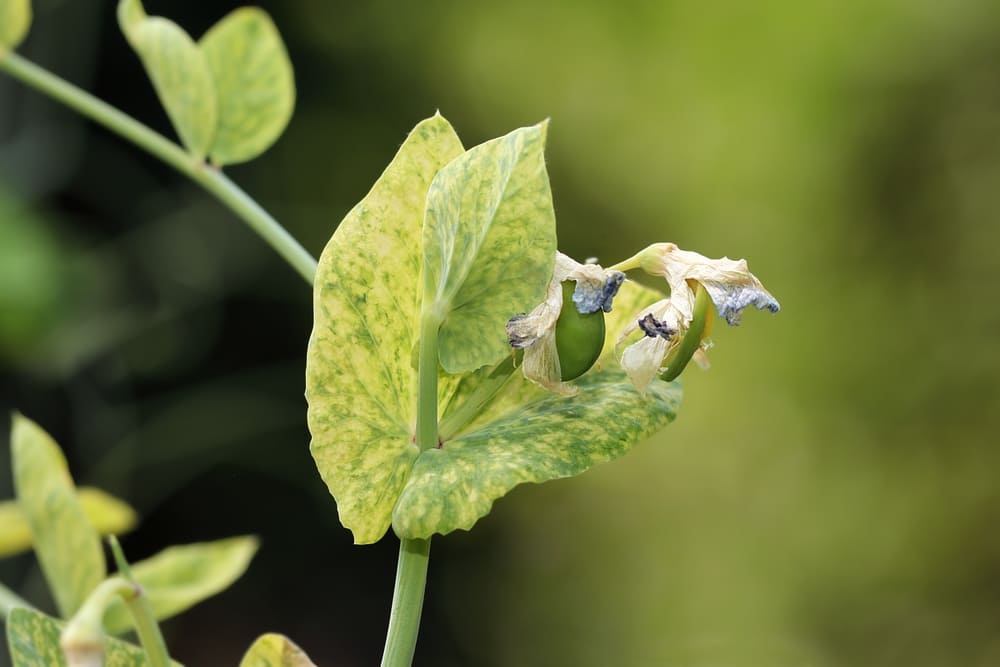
xmin=392 ymin=283 xmax=681 ymax=538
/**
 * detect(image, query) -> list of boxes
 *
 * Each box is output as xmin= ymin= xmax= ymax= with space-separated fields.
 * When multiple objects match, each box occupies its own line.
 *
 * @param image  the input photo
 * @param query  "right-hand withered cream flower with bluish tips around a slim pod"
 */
xmin=612 ymin=243 xmax=780 ymax=392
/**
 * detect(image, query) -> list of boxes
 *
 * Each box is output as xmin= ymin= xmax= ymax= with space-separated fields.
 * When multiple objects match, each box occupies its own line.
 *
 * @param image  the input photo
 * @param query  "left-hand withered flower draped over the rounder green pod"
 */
xmin=507 ymin=252 xmax=625 ymax=396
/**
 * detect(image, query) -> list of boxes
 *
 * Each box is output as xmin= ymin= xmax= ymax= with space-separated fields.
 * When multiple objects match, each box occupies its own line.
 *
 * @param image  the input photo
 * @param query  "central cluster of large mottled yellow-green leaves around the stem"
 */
xmin=306 ymin=116 xmax=680 ymax=543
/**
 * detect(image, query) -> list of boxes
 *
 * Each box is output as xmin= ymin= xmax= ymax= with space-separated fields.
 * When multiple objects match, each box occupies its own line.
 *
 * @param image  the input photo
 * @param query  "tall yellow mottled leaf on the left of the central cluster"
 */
xmin=306 ymin=116 xmax=462 ymax=544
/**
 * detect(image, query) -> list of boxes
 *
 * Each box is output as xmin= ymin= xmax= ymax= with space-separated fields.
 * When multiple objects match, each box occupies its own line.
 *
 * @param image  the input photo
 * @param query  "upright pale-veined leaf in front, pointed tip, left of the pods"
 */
xmin=423 ymin=123 xmax=556 ymax=373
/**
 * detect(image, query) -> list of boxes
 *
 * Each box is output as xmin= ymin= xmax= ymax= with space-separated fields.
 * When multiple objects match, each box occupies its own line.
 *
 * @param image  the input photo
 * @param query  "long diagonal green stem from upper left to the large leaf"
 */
xmin=0 ymin=52 xmax=316 ymax=284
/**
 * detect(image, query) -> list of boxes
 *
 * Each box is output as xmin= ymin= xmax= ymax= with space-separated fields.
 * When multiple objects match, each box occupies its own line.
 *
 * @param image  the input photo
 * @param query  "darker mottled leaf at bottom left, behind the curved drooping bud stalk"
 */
xmin=7 ymin=608 xmax=180 ymax=667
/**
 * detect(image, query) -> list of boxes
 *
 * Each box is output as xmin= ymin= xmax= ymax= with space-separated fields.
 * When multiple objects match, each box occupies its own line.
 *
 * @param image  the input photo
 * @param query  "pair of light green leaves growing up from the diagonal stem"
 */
xmin=118 ymin=0 xmax=295 ymax=165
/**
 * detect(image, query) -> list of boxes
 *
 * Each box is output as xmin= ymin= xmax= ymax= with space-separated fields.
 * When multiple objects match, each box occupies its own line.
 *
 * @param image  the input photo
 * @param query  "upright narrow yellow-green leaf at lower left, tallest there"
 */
xmin=10 ymin=414 xmax=106 ymax=618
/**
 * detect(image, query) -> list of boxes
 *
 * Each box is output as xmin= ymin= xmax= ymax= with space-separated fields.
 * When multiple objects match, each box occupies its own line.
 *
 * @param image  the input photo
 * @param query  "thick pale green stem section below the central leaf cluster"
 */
xmin=382 ymin=539 xmax=431 ymax=667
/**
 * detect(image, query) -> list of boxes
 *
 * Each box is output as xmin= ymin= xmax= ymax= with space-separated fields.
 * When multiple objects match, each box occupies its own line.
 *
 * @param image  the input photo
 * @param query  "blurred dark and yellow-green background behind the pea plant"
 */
xmin=0 ymin=0 xmax=1000 ymax=667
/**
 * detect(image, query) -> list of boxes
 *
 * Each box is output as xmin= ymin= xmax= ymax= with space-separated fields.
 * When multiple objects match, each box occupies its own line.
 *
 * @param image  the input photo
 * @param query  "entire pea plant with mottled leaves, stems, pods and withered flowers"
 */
xmin=0 ymin=0 xmax=778 ymax=667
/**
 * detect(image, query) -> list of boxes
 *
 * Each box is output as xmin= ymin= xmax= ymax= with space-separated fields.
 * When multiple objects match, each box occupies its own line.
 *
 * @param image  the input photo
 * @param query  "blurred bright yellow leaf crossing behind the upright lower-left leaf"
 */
xmin=0 ymin=487 xmax=138 ymax=558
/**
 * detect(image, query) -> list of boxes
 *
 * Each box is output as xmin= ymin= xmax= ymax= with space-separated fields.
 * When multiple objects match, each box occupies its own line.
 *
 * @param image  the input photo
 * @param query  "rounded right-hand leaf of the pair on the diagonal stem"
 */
xmin=200 ymin=7 xmax=295 ymax=165
